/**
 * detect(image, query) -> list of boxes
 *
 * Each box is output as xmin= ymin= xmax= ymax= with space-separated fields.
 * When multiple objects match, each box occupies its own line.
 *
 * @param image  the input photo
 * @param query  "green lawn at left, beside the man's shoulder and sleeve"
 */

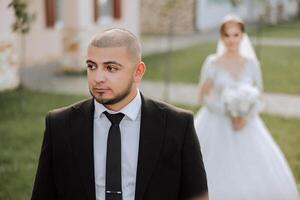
xmin=0 ymin=90 xmax=85 ymax=200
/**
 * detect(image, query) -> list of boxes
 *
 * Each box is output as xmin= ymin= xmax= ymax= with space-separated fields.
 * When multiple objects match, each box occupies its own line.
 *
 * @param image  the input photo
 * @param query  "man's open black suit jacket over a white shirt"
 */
xmin=32 ymin=97 xmax=207 ymax=200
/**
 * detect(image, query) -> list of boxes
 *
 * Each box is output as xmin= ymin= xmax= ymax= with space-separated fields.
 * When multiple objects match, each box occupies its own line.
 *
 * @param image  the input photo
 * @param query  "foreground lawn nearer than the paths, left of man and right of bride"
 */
xmin=0 ymin=89 xmax=300 ymax=200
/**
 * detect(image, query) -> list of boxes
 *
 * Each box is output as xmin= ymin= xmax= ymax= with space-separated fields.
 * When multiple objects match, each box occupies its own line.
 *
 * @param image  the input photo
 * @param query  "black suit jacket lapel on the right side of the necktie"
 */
xmin=135 ymin=96 xmax=165 ymax=200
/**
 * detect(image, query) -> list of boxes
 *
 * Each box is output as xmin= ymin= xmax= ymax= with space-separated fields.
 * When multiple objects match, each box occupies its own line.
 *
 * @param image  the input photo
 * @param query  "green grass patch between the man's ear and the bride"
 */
xmin=144 ymin=43 xmax=215 ymax=83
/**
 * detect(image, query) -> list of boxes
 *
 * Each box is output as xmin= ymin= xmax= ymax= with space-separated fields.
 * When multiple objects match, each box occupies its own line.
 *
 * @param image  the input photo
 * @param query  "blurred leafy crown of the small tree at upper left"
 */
xmin=8 ymin=0 xmax=35 ymax=34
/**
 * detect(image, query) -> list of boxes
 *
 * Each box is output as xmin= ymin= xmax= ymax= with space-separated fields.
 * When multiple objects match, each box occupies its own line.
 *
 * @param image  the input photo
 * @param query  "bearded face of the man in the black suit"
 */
xmin=87 ymin=46 xmax=144 ymax=110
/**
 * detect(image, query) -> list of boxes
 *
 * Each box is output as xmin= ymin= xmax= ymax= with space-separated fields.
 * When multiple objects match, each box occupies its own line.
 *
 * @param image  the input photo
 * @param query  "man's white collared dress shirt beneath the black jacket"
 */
xmin=94 ymin=91 xmax=142 ymax=200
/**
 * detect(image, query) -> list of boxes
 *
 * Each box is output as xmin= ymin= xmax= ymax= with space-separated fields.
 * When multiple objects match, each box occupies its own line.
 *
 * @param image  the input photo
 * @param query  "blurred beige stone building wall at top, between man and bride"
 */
xmin=140 ymin=0 xmax=196 ymax=34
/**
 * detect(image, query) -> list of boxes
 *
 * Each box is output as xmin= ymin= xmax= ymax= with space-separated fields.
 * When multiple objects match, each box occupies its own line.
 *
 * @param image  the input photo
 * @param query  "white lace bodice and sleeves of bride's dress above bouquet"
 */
xmin=200 ymin=55 xmax=262 ymax=113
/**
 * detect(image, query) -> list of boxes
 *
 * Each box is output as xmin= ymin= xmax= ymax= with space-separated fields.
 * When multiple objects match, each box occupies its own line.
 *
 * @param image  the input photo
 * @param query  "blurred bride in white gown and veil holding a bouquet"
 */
xmin=195 ymin=16 xmax=300 ymax=200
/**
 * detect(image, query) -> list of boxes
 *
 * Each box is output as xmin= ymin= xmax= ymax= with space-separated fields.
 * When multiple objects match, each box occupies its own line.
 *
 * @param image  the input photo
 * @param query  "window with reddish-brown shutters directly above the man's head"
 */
xmin=94 ymin=0 xmax=121 ymax=23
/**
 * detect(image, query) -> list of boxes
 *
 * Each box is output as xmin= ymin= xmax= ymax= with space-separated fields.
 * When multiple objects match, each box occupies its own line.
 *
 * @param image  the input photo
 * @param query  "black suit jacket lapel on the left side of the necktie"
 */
xmin=70 ymin=99 xmax=95 ymax=200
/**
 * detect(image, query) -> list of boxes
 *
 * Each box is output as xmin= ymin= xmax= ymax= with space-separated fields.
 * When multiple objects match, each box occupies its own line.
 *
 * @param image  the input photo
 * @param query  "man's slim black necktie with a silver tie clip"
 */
xmin=104 ymin=111 xmax=124 ymax=200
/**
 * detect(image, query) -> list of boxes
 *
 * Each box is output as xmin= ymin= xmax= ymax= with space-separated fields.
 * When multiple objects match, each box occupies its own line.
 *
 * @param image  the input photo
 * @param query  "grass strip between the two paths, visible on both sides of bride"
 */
xmin=144 ymin=43 xmax=300 ymax=94
